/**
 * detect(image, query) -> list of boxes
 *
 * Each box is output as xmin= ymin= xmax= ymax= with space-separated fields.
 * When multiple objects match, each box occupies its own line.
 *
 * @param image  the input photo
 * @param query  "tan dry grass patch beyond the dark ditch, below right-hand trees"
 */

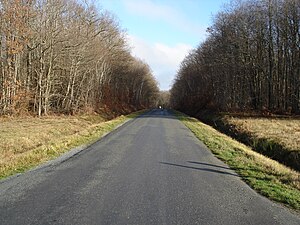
xmin=225 ymin=116 xmax=300 ymax=151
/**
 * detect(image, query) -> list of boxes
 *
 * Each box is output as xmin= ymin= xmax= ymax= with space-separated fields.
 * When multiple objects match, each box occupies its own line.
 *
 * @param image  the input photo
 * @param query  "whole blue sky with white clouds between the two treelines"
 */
xmin=97 ymin=0 xmax=230 ymax=90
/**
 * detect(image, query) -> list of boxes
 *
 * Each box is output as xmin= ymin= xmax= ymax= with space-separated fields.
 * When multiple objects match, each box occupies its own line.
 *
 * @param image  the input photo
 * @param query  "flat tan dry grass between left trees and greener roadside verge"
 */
xmin=0 ymin=116 xmax=103 ymax=156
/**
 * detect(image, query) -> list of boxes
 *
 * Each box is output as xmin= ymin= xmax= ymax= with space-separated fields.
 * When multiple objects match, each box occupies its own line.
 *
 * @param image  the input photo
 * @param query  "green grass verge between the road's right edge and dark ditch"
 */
xmin=178 ymin=114 xmax=300 ymax=210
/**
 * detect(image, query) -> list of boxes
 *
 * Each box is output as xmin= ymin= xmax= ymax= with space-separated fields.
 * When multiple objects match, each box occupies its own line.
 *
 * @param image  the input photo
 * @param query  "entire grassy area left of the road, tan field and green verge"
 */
xmin=0 ymin=112 xmax=141 ymax=179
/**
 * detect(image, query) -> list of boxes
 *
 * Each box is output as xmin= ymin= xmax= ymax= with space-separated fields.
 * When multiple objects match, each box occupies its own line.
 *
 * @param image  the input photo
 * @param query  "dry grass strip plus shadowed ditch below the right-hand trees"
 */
xmin=201 ymin=114 xmax=300 ymax=171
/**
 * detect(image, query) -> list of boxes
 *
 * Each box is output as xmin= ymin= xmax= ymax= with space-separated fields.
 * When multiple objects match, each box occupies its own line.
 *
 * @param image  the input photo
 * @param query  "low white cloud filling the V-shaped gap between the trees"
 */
xmin=128 ymin=35 xmax=192 ymax=90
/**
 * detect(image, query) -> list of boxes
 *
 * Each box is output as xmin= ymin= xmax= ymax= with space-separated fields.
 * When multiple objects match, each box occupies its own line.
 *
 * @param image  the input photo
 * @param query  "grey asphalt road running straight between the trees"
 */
xmin=0 ymin=110 xmax=300 ymax=225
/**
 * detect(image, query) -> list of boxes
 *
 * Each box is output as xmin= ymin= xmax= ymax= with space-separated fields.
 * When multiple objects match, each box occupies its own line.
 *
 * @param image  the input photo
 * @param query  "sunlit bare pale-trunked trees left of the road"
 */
xmin=0 ymin=0 xmax=159 ymax=116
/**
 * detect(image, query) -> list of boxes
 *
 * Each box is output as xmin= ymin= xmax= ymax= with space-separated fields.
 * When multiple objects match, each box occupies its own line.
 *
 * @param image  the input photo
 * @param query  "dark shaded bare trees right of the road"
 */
xmin=171 ymin=0 xmax=300 ymax=114
